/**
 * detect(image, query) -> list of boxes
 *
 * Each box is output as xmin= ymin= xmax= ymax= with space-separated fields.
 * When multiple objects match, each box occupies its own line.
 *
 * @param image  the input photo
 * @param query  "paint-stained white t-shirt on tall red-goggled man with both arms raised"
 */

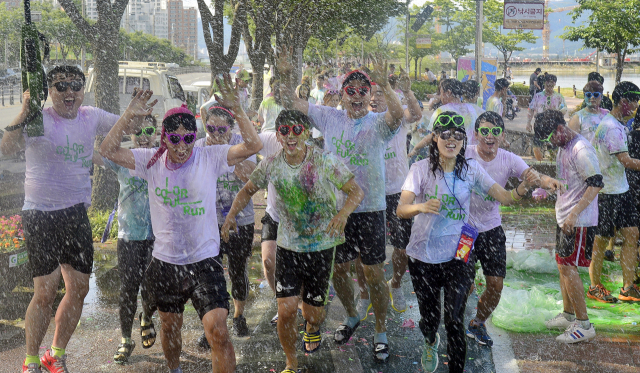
xmin=309 ymin=105 xmax=397 ymax=213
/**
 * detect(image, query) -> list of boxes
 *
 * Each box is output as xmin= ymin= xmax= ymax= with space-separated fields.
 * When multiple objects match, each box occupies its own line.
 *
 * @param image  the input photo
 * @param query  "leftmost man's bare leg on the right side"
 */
xmin=52 ymin=264 xmax=89 ymax=348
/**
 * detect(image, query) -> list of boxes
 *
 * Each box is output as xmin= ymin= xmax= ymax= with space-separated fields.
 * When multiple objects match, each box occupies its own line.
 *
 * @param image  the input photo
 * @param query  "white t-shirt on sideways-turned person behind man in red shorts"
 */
xmin=593 ymin=114 xmax=629 ymax=194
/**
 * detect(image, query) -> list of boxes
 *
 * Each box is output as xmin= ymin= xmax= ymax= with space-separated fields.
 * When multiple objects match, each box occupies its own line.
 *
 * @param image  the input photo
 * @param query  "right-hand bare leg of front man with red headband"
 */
xmin=202 ymin=308 xmax=236 ymax=373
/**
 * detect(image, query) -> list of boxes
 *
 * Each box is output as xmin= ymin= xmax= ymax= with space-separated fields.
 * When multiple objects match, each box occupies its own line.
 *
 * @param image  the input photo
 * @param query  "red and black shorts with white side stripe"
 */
xmin=556 ymin=227 xmax=596 ymax=267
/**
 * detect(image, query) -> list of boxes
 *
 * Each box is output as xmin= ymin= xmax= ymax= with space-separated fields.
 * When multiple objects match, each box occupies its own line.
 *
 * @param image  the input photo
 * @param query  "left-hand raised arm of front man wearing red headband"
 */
xmin=100 ymin=90 xmax=158 ymax=170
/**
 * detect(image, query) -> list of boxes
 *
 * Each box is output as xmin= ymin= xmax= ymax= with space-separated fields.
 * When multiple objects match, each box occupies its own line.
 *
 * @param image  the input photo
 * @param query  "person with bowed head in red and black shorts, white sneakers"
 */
xmin=535 ymin=110 xmax=604 ymax=343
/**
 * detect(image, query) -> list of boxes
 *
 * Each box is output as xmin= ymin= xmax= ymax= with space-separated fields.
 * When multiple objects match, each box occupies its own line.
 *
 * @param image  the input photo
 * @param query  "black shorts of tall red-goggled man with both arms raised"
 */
xmin=336 ymin=211 xmax=387 ymax=265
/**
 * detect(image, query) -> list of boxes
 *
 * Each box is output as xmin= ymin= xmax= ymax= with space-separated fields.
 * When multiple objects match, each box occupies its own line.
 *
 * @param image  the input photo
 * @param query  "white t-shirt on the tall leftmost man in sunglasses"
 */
xmin=22 ymin=106 xmax=120 ymax=211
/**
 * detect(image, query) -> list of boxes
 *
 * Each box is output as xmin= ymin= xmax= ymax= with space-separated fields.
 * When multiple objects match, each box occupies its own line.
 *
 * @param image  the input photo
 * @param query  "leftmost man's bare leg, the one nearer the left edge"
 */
xmin=24 ymin=267 xmax=60 ymax=356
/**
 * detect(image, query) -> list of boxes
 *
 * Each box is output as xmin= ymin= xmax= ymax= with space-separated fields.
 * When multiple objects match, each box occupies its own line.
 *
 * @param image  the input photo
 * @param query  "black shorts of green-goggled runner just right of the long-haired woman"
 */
xmin=471 ymin=226 xmax=507 ymax=278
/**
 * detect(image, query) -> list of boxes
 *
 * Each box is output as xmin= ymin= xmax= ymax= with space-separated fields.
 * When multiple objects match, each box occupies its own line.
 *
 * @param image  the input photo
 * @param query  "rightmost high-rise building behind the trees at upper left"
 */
xmin=167 ymin=0 xmax=198 ymax=55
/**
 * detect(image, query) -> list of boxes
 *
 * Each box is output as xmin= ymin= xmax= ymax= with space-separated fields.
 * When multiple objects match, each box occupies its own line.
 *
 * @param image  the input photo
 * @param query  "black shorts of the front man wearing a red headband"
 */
xmin=143 ymin=257 xmax=229 ymax=320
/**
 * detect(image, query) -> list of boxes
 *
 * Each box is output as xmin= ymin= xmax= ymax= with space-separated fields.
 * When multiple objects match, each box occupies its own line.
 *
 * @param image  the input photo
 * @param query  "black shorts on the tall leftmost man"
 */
xmin=22 ymin=203 xmax=93 ymax=278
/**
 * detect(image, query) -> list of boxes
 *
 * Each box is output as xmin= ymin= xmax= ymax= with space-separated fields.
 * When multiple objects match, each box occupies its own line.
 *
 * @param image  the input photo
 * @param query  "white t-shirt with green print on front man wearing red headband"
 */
xmin=131 ymin=145 xmax=234 ymax=265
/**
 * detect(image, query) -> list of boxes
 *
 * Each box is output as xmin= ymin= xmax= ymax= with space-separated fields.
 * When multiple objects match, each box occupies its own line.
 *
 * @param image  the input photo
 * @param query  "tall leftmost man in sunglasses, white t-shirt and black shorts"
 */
xmin=0 ymin=66 xmax=132 ymax=373
